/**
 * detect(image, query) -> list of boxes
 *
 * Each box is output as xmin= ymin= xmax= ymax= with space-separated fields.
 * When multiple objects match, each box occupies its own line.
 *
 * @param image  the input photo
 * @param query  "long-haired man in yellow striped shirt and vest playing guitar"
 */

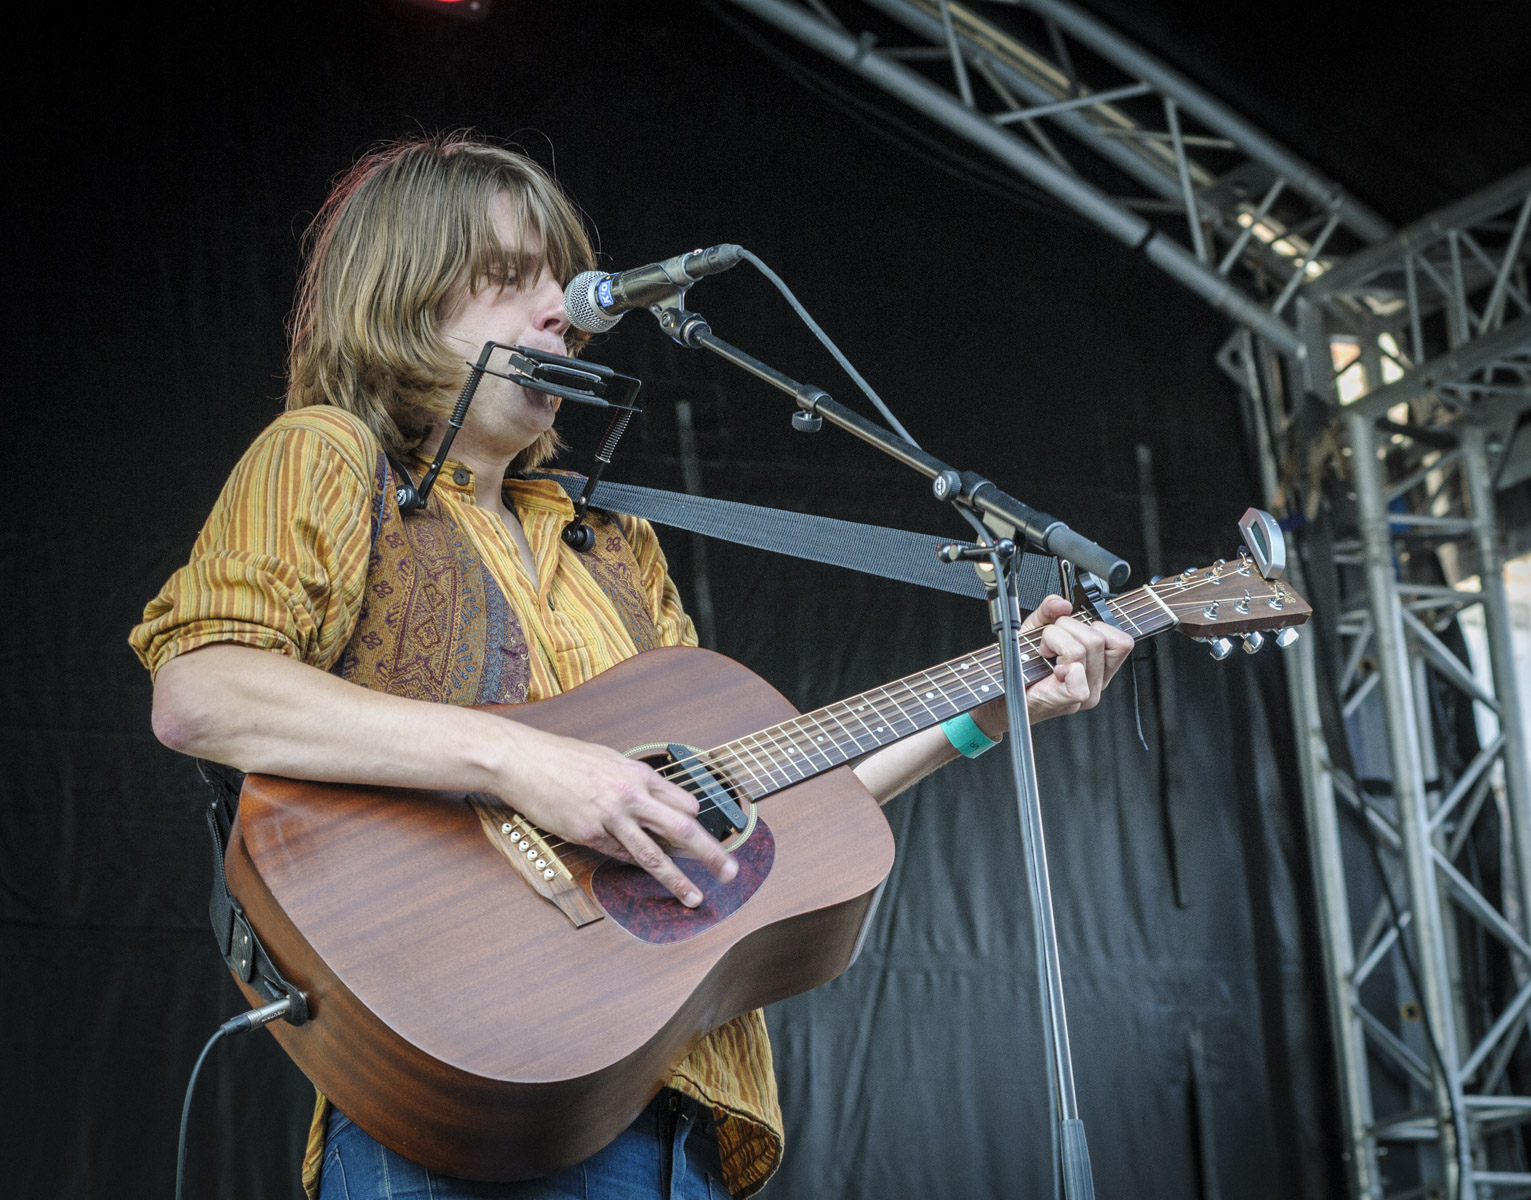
xmin=132 ymin=135 xmax=1133 ymax=1200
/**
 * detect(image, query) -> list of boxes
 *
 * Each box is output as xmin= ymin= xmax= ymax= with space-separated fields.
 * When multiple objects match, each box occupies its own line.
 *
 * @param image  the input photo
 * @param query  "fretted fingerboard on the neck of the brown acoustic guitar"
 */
xmin=703 ymin=586 xmax=1177 ymax=799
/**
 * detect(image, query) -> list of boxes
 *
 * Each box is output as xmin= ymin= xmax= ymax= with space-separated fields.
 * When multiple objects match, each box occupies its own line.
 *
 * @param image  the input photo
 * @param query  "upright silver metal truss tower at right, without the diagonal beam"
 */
xmin=1279 ymin=170 xmax=1531 ymax=1197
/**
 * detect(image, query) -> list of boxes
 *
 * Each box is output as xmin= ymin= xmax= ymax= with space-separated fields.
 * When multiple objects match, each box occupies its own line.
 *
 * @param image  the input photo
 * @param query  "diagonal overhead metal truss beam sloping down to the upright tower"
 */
xmin=733 ymin=0 xmax=1392 ymax=357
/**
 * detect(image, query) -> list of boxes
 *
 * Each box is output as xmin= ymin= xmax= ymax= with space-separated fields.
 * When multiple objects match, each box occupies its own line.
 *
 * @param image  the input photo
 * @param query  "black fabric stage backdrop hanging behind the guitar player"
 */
xmin=0 ymin=0 xmax=1518 ymax=1200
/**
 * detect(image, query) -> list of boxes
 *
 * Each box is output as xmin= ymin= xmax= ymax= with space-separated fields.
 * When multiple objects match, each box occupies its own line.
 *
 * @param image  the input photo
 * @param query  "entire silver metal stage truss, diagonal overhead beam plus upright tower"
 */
xmin=732 ymin=0 xmax=1531 ymax=1200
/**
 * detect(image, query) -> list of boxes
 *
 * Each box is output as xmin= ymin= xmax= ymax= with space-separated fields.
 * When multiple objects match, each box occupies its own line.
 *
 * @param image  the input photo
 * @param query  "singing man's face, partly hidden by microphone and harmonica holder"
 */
xmin=441 ymin=194 xmax=570 ymax=461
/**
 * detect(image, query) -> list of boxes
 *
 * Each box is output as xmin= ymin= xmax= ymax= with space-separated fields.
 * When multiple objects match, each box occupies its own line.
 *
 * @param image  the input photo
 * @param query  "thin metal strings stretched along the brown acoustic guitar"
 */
xmin=522 ymin=568 xmax=1275 ymax=860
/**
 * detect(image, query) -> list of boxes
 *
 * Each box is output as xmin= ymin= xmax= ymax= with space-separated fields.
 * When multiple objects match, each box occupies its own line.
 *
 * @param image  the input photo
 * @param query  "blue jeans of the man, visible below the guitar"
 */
xmin=318 ymin=1088 xmax=729 ymax=1200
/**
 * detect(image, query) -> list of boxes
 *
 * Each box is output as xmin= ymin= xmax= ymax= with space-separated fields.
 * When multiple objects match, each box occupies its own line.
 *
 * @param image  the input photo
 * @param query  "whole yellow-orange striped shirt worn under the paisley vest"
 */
xmin=129 ymin=407 xmax=782 ymax=1197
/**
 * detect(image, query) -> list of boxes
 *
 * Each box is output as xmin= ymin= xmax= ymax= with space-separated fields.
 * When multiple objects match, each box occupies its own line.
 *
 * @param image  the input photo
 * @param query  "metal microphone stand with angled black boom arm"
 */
xmin=651 ymin=300 xmax=1130 ymax=1200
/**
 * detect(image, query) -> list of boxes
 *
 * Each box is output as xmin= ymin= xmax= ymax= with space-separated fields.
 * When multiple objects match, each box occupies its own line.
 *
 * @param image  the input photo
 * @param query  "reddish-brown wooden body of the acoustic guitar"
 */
xmin=227 ymin=647 xmax=893 ymax=1180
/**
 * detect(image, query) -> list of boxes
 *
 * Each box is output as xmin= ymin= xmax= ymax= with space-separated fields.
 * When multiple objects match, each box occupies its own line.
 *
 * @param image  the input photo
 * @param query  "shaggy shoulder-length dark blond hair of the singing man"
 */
xmin=286 ymin=132 xmax=596 ymax=471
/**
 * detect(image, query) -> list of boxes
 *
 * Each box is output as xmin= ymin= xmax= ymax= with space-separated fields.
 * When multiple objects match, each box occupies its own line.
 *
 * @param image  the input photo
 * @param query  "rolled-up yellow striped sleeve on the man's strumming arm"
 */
xmin=129 ymin=409 xmax=377 ymax=673
